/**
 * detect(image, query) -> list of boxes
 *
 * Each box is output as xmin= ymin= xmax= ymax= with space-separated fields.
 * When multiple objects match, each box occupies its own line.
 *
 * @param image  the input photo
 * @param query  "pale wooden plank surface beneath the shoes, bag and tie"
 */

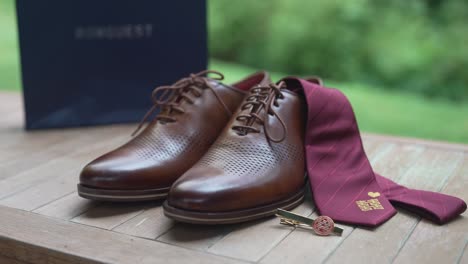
xmin=0 ymin=93 xmax=468 ymax=264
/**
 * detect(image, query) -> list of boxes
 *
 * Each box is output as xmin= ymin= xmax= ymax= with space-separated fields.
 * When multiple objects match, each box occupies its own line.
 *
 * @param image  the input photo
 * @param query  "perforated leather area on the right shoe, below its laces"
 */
xmin=195 ymin=140 xmax=304 ymax=176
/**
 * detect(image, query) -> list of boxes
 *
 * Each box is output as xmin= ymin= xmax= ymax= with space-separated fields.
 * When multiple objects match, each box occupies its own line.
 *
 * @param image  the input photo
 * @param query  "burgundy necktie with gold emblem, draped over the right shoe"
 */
xmin=283 ymin=78 xmax=466 ymax=226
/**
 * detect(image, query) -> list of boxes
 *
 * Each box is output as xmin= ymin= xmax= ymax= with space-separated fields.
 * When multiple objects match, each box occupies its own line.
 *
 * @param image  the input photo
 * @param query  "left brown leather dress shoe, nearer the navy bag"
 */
xmin=78 ymin=71 xmax=270 ymax=201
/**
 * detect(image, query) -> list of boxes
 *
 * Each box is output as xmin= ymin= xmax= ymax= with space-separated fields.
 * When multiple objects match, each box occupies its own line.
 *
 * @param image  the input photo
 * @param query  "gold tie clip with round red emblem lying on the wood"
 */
xmin=276 ymin=208 xmax=343 ymax=236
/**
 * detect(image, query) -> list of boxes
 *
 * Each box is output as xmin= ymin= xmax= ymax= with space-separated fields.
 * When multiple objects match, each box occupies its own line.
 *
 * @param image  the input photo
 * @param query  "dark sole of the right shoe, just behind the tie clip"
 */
xmin=163 ymin=189 xmax=304 ymax=225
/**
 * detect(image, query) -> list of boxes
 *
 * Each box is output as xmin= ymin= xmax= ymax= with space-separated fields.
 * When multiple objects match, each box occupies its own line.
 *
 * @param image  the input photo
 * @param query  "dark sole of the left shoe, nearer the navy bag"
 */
xmin=78 ymin=184 xmax=170 ymax=202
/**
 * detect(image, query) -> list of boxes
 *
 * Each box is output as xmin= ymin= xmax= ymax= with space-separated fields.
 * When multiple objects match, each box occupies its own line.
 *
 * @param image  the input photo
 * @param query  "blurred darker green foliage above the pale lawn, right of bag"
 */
xmin=209 ymin=0 xmax=468 ymax=101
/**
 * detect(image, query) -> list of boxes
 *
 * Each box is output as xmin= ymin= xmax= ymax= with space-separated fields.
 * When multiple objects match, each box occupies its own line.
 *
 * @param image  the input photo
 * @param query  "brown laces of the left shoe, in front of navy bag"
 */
xmin=132 ymin=70 xmax=232 ymax=136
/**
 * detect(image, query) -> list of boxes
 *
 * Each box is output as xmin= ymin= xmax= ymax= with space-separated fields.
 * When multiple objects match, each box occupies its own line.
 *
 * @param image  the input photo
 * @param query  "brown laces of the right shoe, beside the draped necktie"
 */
xmin=232 ymin=82 xmax=287 ymax=143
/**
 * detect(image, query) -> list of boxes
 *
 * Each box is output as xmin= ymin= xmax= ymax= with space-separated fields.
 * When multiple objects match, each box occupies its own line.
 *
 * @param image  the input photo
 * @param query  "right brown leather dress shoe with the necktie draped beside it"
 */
xmin=163 ymin=84 xmax=307 ymax=224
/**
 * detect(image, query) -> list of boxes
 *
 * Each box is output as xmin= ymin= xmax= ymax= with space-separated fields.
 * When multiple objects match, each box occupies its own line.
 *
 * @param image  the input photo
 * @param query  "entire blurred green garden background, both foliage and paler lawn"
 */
xmin=0 ymin=0 xmax=468 ymax=143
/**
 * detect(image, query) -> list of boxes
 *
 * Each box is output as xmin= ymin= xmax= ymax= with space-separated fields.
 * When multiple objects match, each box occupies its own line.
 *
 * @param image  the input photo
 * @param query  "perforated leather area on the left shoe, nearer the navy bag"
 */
xmin=131 ymin=129 xmax=213 ymax=161
